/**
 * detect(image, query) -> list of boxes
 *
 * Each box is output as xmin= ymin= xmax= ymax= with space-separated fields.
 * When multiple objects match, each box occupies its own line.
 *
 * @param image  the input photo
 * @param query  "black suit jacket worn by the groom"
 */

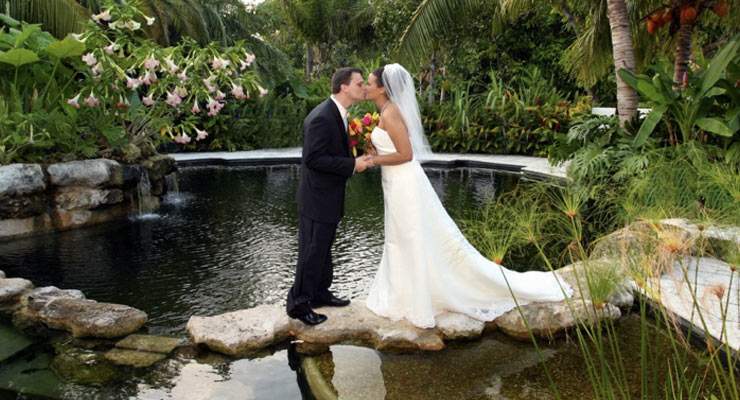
xmin=298 ymin=98 xmax=355 ymax=224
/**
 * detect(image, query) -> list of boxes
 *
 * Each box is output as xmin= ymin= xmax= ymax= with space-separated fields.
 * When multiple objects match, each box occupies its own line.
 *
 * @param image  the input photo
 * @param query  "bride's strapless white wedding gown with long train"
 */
xmin=367 ymin=127 xmax=572 ymax=328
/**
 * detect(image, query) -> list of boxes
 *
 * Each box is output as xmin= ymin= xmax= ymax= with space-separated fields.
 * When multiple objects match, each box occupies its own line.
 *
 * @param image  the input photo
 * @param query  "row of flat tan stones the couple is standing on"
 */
xmin=187 ymin=290 xmax=621 ymax=357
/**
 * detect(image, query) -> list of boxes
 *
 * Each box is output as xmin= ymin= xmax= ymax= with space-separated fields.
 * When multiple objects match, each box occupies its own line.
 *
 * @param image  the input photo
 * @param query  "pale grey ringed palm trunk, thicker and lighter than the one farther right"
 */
xmin=606 ymin=0 xmax=639 ymax=126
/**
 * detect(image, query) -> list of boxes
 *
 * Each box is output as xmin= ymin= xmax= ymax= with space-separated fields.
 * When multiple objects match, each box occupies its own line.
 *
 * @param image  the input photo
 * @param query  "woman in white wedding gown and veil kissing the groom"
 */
xmin=367 ymin=64 xmax=573 ymax=328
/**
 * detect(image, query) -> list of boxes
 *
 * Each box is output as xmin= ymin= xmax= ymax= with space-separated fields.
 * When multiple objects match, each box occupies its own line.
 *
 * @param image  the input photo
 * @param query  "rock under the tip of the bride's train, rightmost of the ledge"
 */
xmin=496 ymin=300 xmax=622 ymax=341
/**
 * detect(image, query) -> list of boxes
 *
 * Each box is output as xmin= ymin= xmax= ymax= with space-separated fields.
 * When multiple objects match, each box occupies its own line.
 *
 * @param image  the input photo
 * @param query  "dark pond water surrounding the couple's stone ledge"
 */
xmin=0 ymin=167 xmax=724 ymax=400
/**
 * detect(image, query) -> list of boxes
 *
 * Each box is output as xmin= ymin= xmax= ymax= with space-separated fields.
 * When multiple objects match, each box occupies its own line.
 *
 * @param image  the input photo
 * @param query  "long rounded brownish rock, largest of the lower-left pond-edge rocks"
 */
xmin=38 ymin=298 xmax=147 ymax=338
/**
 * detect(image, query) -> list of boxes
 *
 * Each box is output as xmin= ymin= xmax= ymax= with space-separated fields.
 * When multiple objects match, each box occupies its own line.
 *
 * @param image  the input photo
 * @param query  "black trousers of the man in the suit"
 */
xmin=287 ymin=215 xmax=338 ymax=316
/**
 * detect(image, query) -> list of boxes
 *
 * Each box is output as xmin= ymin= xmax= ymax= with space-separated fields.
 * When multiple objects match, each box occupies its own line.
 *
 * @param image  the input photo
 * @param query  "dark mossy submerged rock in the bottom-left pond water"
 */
xmin=50 ymin=346 xmax=121 ymax=385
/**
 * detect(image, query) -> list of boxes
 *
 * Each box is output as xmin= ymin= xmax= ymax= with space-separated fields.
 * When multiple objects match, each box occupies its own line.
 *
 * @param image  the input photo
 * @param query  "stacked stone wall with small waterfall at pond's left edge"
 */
xmin=0 ymin=156 xmax=175 ymax=240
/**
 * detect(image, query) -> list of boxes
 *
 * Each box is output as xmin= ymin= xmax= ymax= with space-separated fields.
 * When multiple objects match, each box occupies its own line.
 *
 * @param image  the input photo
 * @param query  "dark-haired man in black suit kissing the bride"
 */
xmin=287 ymin=68 xmax=370 ymax=325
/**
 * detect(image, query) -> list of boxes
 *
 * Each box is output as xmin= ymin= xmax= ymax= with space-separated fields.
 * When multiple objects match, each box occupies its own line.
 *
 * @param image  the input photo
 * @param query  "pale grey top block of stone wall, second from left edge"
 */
xmin=47 ymin=158 xmax=123 ymax=187
